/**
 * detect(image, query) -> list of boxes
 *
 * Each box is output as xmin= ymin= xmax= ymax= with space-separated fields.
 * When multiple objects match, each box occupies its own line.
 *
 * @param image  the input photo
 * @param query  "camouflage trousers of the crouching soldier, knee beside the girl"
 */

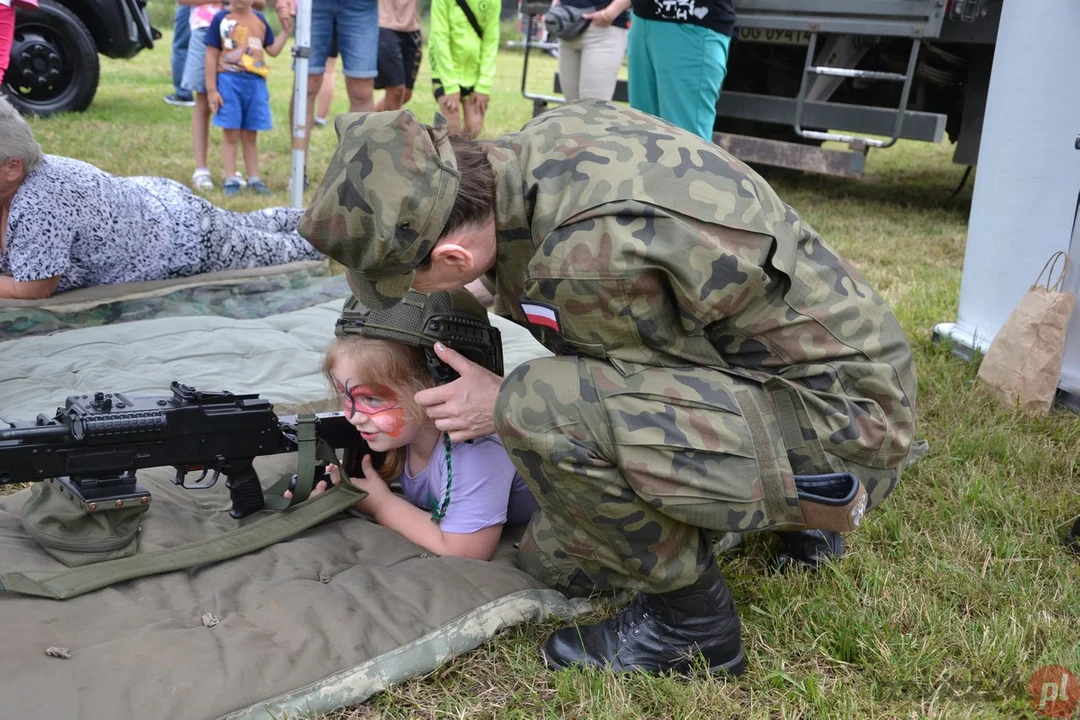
xmin=496 ymin=357 xmax=900 ymax=593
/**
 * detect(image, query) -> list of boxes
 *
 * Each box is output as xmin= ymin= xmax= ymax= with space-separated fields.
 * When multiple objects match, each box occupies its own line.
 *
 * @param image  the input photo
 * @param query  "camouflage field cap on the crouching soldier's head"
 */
xmin=298 ymin=110 xmax=461 ymax=308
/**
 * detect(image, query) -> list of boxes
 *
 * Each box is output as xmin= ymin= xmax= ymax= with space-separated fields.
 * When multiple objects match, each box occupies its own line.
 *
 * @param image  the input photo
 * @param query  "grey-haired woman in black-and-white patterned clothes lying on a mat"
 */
xmin=0 ymin=96 xmax=323 ymax=299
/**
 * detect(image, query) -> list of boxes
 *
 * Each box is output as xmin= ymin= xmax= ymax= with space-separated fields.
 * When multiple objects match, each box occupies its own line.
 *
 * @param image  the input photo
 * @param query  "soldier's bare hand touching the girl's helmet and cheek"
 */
xmin=416 ymin=342 xmax=502 ymax=443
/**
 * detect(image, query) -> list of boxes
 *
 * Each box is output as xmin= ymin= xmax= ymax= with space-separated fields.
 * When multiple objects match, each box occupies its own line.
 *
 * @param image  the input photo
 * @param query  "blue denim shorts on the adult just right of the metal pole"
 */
xmin=308 ymin=0 xmax=379 ymax=78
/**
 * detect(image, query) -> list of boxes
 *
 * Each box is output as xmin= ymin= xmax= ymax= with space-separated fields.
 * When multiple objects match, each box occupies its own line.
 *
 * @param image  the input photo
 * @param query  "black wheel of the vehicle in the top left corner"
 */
xmin=3 ymin=0 xmax=98 ymax=116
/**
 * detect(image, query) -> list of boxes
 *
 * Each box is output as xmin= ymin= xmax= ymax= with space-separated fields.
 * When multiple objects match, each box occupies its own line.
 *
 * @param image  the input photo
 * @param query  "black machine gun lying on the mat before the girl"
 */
xmin=0 ymin=382 xmax=367 ymax=519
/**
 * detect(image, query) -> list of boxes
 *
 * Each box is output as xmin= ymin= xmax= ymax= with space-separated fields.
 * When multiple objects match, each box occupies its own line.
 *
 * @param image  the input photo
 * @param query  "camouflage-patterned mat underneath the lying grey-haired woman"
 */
xmin=0 ymin=262 xmax=349 ymax=341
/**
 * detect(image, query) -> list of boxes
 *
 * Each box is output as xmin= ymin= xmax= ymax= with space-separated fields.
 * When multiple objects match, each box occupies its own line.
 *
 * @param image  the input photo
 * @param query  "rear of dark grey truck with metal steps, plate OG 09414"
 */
xmin=522 ymin=0 xmax=1003 ymax=177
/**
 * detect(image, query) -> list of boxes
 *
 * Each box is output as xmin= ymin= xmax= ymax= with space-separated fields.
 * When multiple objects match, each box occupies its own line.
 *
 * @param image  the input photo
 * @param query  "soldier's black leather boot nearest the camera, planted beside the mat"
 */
xmin=543 ymin=561 xmax=746 ymax=676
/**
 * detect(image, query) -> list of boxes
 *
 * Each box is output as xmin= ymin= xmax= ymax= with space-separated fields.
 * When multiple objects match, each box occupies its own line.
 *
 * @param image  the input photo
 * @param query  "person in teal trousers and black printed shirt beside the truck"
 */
xmin=596 ymin=0 xmax=735 ymax=140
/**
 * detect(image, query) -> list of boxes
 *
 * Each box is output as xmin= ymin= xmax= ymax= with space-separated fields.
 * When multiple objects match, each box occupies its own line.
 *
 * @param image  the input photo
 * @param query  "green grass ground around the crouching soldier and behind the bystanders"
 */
xmin=16 ymin=25 xmax=1080 ymax=720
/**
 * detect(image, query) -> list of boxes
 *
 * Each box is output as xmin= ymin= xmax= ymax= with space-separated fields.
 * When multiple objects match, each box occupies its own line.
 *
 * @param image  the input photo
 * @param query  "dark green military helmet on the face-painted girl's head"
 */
xmin=334 ymin=289 xmax=502 ymax=383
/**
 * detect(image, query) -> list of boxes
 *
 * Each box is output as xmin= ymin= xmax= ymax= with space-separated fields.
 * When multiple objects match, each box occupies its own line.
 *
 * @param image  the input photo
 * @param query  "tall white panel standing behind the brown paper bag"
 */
xmin=934 ymin=0 xmax=1080 ymax=396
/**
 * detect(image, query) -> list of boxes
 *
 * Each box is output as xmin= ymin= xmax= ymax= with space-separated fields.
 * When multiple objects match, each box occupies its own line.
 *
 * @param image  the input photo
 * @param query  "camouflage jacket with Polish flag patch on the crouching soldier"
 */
xmin=486 ymin=100 xmax=916 ymax=467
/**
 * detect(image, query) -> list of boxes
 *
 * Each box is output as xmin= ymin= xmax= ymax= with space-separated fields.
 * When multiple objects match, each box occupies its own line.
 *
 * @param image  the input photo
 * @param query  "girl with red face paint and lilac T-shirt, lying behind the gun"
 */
xmin=302 ymin=335 xmax=537 ymax=560
